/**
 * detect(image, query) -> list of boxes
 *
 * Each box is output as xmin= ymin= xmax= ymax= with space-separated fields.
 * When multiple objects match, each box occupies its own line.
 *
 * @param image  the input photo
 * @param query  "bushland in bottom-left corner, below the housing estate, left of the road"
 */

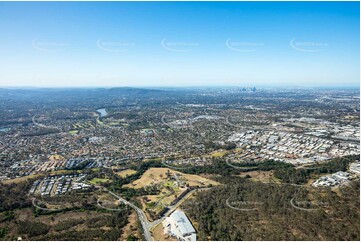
xmin=0 ymin=180 xmax=131 ymax=240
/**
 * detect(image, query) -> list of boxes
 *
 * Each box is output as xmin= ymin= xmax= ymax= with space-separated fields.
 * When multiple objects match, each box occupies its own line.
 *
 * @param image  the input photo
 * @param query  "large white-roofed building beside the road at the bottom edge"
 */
xmin=163 ymin=210 xmax=197 ymax=241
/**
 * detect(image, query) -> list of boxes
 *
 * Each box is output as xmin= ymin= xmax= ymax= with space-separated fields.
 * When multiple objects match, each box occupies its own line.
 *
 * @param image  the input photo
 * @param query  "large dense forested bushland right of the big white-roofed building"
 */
xmin=183 ymin=177 xmax=360 ymax=240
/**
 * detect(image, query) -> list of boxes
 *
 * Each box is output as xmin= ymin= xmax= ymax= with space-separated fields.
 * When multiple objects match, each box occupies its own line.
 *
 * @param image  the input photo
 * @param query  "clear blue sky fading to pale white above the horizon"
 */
xmin=0 ymin=2 xmax=360 ymax=87
